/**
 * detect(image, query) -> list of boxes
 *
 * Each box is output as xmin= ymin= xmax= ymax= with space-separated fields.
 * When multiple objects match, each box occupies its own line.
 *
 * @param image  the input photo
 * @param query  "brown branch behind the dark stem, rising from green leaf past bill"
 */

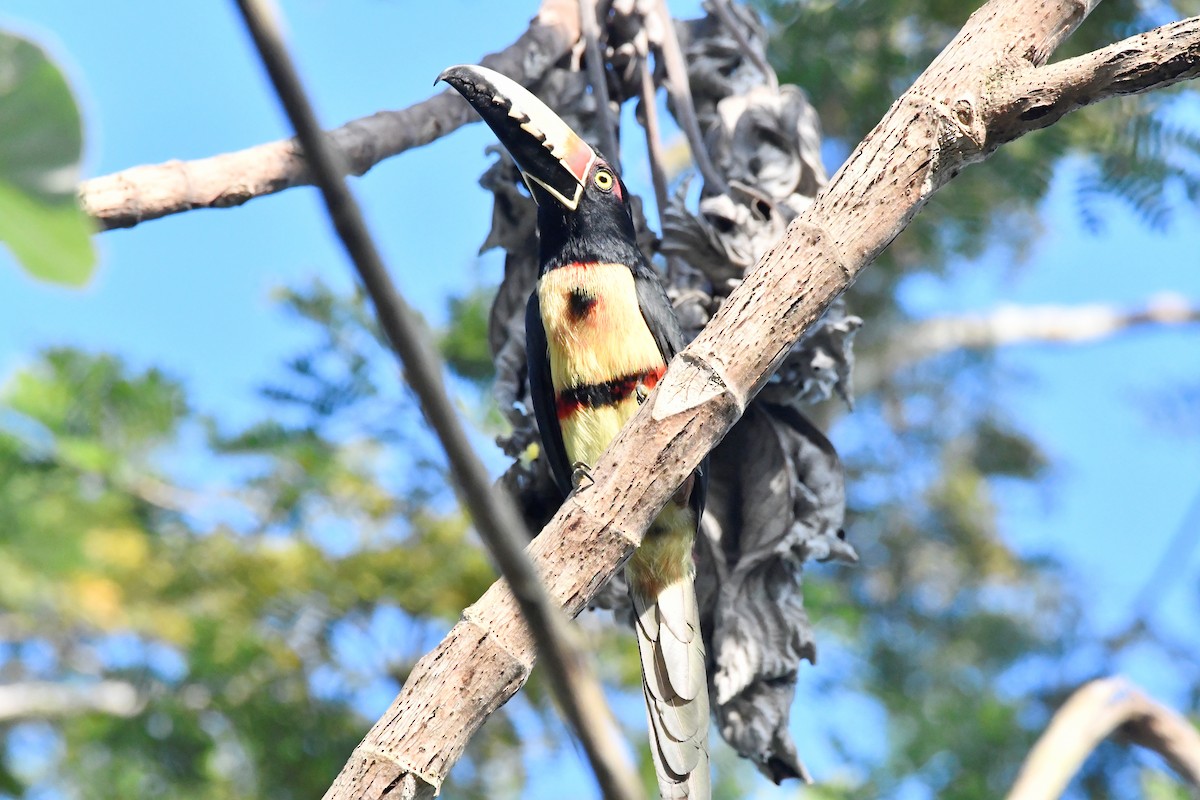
xmin=79 ymin=0 xmax=580 ymax=230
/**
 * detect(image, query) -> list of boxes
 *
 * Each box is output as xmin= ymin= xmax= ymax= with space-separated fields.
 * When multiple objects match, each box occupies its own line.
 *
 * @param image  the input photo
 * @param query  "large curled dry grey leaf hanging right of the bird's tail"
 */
xmin=697 ymin=402 xmax=858 ymax=782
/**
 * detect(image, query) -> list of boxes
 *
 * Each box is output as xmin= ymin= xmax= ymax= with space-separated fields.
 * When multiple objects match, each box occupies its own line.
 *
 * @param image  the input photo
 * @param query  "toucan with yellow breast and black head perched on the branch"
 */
xmin=438 ymin=65 xmax=710 ymax=800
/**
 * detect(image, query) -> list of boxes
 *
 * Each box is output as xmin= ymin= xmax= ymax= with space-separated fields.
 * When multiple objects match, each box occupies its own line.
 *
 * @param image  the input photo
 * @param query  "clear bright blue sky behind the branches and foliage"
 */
xmin=0 ymin=0 xmax=1200 ymax=796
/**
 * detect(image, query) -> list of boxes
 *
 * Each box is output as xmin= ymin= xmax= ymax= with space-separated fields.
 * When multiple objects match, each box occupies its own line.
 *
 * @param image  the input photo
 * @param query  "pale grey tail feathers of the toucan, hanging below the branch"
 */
xmin=630 ymin=568 xmax=712 ymax=800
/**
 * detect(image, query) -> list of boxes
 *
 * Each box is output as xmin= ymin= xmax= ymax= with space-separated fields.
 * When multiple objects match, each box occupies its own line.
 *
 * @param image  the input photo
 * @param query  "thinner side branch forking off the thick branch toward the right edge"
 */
xmin=995 ymin=17 xmax=1200 ymax=144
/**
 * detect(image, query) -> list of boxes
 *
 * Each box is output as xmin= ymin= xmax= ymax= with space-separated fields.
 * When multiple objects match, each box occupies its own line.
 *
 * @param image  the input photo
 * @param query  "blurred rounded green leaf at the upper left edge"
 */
xmin=0 ymin=31 xmax=96 ymax=285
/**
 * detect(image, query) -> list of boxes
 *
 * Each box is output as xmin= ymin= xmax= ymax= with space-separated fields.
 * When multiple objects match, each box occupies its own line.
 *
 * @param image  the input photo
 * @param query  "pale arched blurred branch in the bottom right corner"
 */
xmin=1008 ymin=678 xmax=1200 ymax=800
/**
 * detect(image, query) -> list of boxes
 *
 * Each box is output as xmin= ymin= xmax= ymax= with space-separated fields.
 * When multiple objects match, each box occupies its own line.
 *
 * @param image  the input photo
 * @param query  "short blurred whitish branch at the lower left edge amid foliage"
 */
xmin=0 ymin=680 xmax=145 ymax=722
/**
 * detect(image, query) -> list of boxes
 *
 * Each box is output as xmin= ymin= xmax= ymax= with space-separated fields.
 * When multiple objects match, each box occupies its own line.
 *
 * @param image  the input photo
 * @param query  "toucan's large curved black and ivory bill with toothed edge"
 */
xmin=438 ymin=65 xmax=596 ymax=211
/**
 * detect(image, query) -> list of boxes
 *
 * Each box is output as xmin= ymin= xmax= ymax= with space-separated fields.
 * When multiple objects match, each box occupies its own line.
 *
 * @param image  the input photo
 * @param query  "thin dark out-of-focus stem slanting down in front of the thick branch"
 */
xmin=225 ymin=0 xmax=641 ymax=799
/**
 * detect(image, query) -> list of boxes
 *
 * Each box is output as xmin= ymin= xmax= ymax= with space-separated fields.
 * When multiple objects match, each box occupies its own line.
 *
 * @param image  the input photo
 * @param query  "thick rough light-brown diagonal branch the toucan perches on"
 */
xmin=316 ymin=0 xmax=1200 ymax=798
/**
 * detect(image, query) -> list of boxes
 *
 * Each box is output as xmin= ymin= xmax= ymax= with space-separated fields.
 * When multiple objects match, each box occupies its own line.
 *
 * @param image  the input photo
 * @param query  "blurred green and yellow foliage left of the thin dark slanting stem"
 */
xmin=0 ymin=287 xmax=516 ymax=798
